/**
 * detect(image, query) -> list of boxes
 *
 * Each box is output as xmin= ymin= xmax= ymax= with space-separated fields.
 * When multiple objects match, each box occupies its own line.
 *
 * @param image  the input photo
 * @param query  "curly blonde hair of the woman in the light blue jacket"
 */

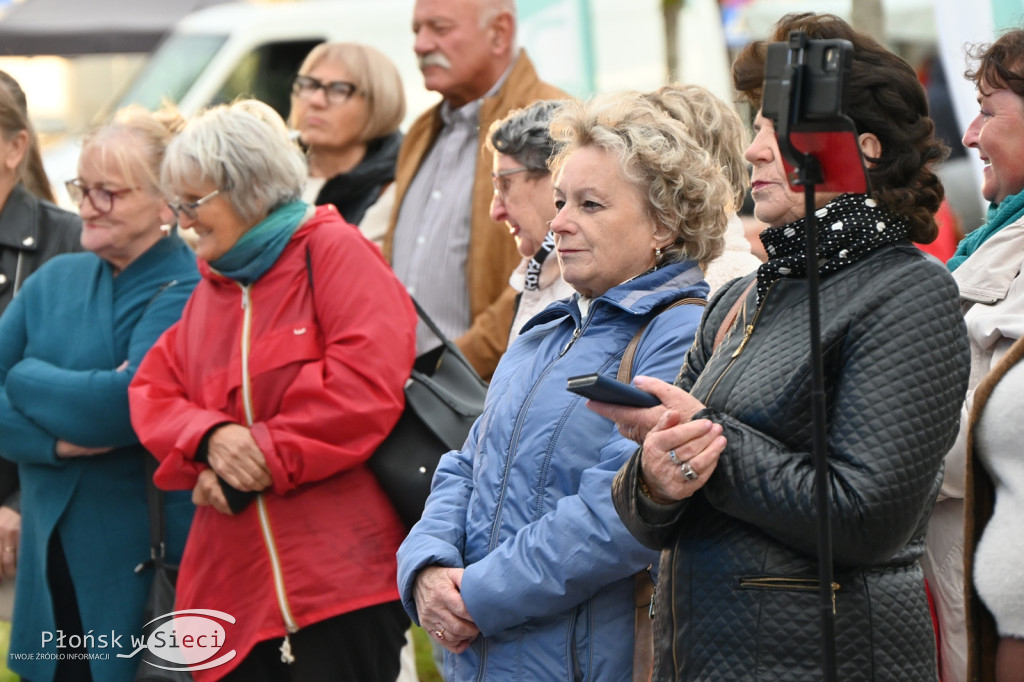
xmin=549 ymin=91 xmax=735 ymax=265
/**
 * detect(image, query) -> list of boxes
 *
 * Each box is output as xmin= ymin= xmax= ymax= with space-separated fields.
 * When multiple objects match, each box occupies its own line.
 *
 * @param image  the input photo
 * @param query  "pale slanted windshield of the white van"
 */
xmin=114 ymin=34 xmax=227 ymax=111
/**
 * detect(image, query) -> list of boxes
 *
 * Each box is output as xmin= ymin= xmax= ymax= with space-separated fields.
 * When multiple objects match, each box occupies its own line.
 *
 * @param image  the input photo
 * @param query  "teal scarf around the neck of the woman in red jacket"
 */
xmin=210 ymin=201 xmax=309 ymax=285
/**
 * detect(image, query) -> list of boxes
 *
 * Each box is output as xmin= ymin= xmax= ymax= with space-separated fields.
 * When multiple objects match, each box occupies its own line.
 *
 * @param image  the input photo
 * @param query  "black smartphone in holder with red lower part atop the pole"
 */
xmin=761 ymin=31 xmax=867 ymax=193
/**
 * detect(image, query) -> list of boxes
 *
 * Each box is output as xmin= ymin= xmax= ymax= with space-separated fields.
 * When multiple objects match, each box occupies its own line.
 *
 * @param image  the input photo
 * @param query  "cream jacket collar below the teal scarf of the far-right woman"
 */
xmin=952 ymin=215 xmax=1024 ymax=305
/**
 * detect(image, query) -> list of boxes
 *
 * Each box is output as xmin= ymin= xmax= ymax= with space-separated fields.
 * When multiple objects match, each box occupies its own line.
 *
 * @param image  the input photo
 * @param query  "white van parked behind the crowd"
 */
xmin=43 ymin=0 xmax=728 ymax=204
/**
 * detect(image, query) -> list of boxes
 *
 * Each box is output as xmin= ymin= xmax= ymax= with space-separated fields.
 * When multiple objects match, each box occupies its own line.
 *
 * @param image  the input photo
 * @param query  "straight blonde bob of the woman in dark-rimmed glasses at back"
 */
xmin=289 ymin=43 xmax=406 ymax=142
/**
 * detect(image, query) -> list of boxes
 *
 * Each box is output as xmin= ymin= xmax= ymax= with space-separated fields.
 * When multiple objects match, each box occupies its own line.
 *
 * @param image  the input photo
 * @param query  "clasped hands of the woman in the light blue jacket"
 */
xmin=413 ymin=566 xmax=480 ymax=653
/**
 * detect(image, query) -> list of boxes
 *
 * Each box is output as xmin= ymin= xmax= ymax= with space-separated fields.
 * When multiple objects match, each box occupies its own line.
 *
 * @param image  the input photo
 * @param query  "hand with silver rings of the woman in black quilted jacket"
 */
xmin=640 ymin=411 xmax=726 ymax=504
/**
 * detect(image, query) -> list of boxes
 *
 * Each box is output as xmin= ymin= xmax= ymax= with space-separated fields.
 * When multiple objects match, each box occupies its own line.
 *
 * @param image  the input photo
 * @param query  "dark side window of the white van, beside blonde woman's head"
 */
xmin=213 ymin=40 xmax=322 ymax=118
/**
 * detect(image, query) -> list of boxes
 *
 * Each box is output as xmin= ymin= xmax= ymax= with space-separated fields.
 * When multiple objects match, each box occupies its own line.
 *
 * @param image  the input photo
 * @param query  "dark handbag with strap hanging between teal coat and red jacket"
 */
xmin=135 ymin=454 xmax=193 ymax=682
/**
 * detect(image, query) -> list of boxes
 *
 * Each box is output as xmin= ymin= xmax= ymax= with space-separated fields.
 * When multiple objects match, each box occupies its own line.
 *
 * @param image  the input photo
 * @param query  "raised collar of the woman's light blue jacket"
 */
xmin=522 ymin=260 xmax=710 ymax=332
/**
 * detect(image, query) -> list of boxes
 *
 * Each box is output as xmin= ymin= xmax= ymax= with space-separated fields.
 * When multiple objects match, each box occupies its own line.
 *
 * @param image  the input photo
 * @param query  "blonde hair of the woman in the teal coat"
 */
xmin=82 ymin=102 xmax=185 ymax=195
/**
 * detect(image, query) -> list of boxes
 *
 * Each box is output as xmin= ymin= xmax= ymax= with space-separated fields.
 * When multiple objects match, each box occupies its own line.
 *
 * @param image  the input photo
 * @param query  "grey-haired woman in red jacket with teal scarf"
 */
xmin=130 ymin=101 xmax=416 ymax=682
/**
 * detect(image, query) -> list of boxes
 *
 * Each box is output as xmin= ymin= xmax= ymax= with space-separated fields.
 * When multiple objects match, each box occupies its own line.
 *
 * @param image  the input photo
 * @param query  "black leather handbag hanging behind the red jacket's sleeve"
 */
xmin=369 ymin=300 xmax=487 ymax=527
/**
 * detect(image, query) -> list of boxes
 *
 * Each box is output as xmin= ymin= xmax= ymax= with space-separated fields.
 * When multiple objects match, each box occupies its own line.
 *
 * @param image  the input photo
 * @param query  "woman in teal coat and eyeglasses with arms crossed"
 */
xmin=0 ymin=102 xmax=199 ymax=681
